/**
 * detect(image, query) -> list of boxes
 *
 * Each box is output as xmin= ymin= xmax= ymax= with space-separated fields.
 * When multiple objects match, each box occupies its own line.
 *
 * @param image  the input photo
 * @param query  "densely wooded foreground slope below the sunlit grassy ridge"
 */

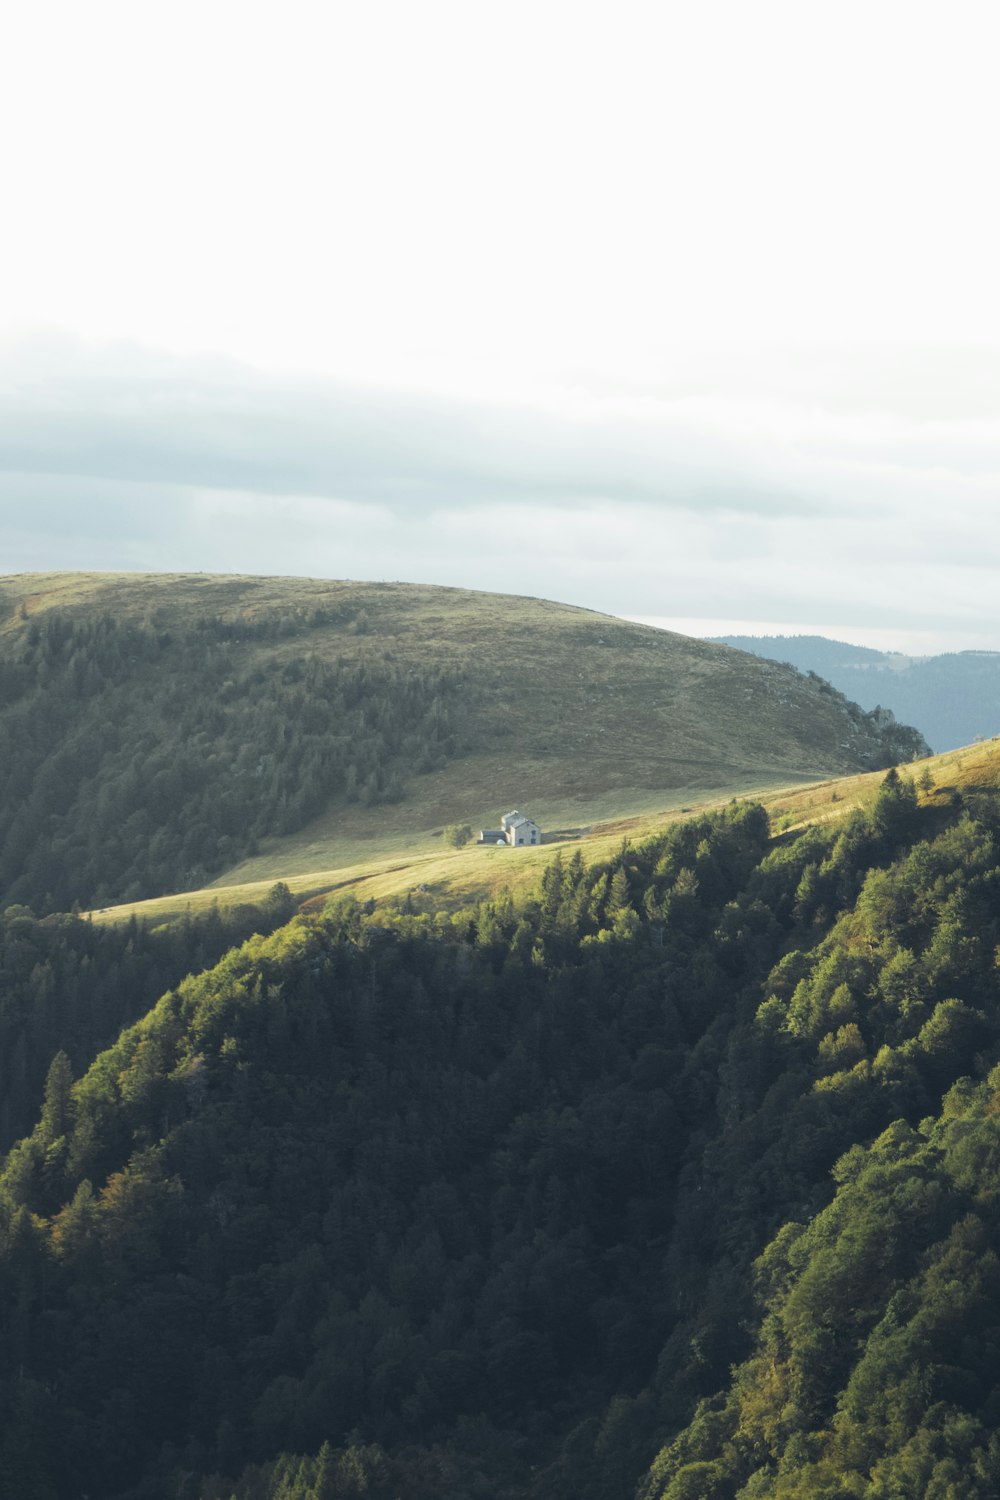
xmin=0 ymin=767 xmax=1000 ymax=1500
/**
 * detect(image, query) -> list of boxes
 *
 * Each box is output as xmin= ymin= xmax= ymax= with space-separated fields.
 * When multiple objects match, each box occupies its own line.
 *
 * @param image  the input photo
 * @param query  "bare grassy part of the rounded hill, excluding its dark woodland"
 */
xmin=0 ymin=573 xmax=929 ymax=884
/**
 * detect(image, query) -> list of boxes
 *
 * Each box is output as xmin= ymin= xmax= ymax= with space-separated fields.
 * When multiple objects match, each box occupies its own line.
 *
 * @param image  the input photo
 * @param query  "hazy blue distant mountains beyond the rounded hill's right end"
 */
xmin=711 ymin=636 xmax=1000 ymax=753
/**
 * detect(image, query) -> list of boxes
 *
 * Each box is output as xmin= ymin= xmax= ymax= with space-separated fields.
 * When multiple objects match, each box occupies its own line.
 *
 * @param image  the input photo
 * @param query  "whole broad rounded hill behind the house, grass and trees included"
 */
xmin=0 ymin=575 xmax=925 ymax=912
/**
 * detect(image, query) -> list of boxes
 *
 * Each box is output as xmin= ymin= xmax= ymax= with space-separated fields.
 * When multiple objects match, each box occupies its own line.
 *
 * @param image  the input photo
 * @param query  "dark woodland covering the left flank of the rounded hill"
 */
xmin=0 ymin=611 xmax=462 ymax=912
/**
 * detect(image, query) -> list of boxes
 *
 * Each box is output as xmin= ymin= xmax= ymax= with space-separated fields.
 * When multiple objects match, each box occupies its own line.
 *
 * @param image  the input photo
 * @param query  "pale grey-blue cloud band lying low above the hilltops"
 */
xmin=0 ymin=341 xmax=1000 ymax=651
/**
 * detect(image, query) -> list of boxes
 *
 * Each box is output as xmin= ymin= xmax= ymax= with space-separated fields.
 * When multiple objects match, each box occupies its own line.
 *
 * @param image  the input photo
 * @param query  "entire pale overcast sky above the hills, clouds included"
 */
xmin=0 ymin=0 xmax=1000 ymax=651
